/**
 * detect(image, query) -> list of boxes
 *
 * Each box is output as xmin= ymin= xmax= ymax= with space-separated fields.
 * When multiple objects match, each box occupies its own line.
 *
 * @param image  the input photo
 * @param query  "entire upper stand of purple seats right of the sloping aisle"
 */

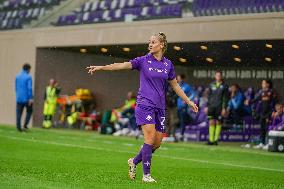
xmin=53 ymin=0 xmax=284 ymax=26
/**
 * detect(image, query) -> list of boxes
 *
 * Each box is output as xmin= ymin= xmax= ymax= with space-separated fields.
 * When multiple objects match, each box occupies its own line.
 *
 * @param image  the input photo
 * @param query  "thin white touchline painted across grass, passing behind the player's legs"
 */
xmin=2 ymin=135 xmax=284 ymax=173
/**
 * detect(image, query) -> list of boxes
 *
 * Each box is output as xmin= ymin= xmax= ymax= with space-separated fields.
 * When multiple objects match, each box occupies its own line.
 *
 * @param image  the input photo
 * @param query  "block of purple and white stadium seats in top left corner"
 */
xmin=0 ymin=0 xmax=65 ymax=30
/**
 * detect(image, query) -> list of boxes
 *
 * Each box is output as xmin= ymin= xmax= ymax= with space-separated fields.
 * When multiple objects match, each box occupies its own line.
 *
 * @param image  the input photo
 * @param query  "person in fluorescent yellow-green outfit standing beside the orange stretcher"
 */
xmin=42 ymin=79 xmax=60 ymax=128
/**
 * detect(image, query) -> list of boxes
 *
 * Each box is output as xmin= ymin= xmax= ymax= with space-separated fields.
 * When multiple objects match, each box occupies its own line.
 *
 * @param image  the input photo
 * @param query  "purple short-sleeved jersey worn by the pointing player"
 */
xmin=130 ymin=53 xmax=176 ymax=109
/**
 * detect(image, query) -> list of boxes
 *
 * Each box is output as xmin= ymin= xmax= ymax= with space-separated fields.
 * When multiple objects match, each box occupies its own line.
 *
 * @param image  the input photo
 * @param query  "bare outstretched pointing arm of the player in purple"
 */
xmin=86 ymin=62 xmax=132 ymax=75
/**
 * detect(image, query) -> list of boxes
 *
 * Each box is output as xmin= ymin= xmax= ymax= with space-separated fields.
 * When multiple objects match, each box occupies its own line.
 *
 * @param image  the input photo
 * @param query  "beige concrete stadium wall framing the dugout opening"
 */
xmin=0 ymin=13 xmax=284 ymax=124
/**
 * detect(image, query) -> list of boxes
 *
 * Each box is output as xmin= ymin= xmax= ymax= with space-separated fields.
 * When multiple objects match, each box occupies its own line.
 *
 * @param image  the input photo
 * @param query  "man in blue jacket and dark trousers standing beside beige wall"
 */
xmin=15 ymin=63 xmax=33 ymax=132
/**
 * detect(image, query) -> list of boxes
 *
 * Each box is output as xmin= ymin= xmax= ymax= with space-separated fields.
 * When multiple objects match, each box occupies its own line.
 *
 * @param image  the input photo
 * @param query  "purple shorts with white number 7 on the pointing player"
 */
xmin=135 ymin=104 xmax=166 ymax=133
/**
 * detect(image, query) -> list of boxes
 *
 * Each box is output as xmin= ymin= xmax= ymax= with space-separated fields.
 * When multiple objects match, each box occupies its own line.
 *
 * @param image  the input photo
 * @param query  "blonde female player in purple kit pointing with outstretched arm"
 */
xmin=86 ymin=32 xmax=198 ymax=182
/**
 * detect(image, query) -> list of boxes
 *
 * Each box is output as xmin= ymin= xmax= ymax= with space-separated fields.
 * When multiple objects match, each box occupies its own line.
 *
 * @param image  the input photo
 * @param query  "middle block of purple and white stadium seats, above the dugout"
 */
xmin=54 ymin=0 xmax=187 ymax=26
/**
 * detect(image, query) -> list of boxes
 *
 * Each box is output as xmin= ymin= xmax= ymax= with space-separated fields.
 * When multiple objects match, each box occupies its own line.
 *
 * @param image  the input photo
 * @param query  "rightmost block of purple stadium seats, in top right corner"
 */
xmin=192 ymin=0 xmax=284 ymax=17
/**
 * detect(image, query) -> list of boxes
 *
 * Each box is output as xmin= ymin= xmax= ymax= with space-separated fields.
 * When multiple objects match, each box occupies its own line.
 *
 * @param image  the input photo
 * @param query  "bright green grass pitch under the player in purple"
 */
xmin=0 ymin=125 xmax=284 ymax=189
